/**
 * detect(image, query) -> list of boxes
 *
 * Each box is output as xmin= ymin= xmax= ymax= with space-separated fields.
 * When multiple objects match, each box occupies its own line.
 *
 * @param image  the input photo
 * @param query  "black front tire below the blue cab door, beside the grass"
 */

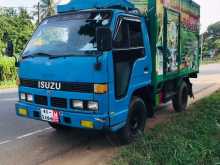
xmin=118 ymin=97 xmax=147 ymax=144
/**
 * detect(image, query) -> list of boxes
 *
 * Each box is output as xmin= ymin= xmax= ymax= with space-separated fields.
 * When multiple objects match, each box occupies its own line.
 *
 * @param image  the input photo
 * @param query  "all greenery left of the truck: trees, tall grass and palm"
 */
xmin=0 ymin=0 xmax=55 ymax=89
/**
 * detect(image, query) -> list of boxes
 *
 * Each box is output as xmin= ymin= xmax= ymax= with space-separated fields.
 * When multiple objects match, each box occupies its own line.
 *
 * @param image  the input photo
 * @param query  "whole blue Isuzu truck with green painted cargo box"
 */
xmin=7 ymin=0 xmax=200 ymax=143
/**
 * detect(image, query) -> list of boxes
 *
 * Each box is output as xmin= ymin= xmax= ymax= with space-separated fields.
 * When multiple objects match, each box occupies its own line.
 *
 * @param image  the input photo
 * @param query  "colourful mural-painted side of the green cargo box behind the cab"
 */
xmin=131 ymin=0 xmax=200 ymax=82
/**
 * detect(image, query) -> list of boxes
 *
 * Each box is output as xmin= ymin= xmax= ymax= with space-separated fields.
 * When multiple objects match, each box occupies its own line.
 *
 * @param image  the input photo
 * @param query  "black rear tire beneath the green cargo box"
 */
xmin=172 ymin=82 xmax=189 ymax=112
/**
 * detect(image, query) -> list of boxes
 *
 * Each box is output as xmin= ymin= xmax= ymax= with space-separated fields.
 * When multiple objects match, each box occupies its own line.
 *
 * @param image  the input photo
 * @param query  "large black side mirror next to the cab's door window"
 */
xmin=96 ymin=27 xmax=112 ymax=52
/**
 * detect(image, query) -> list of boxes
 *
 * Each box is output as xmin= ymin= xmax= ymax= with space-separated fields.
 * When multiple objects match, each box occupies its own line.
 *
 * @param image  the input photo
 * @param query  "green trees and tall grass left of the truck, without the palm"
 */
xmin=0 ymin=8 xmax=34 ymax=83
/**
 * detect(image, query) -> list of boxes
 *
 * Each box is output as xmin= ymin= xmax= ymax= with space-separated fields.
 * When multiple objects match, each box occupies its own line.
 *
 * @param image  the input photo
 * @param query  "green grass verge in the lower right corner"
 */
xmin=112 ymin=92 xmax=220 ymax=165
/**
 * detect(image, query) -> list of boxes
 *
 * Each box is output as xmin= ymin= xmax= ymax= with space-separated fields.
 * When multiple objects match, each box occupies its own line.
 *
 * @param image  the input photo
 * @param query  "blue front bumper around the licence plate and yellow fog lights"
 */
xmin=16 ymin=102 xmax=110 ymax=130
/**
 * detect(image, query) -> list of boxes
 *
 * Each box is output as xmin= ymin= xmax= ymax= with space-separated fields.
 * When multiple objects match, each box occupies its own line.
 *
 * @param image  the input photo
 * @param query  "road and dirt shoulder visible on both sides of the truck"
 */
xmin=0 ymin=64 xmax=220 ymax=165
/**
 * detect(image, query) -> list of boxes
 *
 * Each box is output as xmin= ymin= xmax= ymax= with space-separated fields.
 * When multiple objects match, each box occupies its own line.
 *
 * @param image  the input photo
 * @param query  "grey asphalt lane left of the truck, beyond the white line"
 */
xmin=0 ymin=90 xmax=48 ymax=143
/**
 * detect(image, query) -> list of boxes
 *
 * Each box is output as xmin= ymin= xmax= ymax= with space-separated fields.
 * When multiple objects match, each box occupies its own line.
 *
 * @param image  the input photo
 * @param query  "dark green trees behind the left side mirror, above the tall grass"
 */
xmin=0 ymin=9 xmax=34 ymax=56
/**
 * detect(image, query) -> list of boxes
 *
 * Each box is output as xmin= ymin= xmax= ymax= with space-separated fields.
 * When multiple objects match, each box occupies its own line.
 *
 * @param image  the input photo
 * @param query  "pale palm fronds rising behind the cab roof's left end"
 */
xmin=33 ymin=0 xmax=55 ymax=22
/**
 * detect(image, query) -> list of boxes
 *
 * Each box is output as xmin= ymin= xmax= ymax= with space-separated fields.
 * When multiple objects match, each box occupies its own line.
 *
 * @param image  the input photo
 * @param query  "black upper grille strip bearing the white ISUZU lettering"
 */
xmin=20 ymin=79 xmax=94 ymax=93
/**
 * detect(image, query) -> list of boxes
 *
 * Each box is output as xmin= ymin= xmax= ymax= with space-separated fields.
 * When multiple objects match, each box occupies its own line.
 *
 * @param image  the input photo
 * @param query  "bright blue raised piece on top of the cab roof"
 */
xmin=57 ymin=0 xmax=135 ymax=13
